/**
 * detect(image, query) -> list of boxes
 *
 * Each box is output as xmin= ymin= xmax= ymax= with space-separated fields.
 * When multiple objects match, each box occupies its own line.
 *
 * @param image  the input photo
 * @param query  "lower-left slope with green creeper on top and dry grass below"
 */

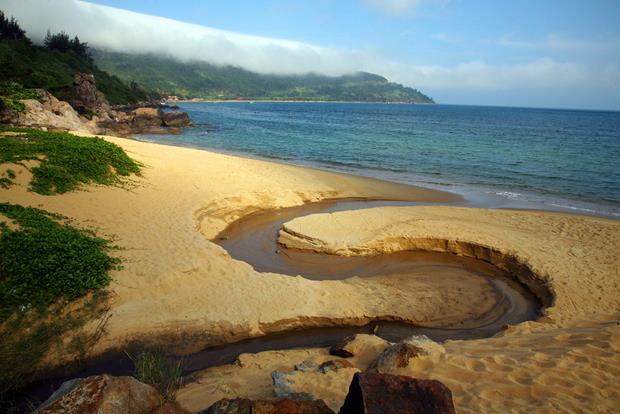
xmin=0 ymin=203 xmax=119 ymax=398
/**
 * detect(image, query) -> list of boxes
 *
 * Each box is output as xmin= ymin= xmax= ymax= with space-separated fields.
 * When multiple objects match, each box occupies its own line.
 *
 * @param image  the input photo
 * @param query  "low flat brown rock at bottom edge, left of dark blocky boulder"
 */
xmin=201 ymin=398 xmax=334 ymax=414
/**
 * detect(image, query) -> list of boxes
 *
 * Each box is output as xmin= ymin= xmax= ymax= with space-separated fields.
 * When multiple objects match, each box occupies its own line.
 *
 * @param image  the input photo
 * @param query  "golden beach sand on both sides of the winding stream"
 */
xmin=0 ymin=137 xmax=620 ymax=412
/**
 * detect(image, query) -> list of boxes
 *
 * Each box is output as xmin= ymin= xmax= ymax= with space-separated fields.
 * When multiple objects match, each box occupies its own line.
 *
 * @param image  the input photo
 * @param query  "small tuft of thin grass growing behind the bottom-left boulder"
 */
xmin=127 ymin=350 xmax=183 ymax=401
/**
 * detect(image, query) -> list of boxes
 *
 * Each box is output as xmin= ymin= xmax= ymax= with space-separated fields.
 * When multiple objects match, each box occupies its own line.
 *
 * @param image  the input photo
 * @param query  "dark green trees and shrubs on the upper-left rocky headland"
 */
xmin=0 ymin=12 xmax=157 ymax=105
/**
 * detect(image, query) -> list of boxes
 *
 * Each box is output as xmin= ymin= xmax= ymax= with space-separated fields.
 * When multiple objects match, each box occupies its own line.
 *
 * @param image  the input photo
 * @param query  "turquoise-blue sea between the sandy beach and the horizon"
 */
xmin=142 ymin=102 xmax=620 ymax=217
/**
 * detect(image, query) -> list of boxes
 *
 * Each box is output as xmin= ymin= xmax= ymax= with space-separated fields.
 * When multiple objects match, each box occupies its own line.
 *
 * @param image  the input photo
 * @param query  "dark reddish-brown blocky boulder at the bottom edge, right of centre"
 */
xmin=339 ymin=372 xmax=455 ymax=414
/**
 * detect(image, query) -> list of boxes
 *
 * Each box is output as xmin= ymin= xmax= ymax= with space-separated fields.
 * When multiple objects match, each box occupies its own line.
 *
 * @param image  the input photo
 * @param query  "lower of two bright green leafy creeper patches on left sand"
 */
xmin=0 ymin=203 xmax=120 ymax=323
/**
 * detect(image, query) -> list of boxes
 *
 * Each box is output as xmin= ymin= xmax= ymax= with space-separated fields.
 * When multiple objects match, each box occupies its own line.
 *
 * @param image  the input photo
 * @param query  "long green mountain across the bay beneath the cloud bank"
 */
xmin=91 ymin=50 xmax=433 ymax=103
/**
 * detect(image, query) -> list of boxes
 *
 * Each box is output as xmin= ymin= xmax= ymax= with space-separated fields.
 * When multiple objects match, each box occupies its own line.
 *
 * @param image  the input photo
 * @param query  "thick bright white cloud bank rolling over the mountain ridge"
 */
xmin=2 ymin=0 xmax=366 ymax=75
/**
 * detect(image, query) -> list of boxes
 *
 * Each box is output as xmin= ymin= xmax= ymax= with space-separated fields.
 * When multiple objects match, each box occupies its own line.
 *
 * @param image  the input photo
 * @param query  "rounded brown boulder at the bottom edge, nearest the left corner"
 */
xmin=37 ymin=375 xmax=188 ymax=414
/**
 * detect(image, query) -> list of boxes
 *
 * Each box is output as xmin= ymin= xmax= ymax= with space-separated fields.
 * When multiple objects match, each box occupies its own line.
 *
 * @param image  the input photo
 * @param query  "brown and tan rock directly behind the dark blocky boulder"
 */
xmin=368 ymin=335 xmax=445 ymax=373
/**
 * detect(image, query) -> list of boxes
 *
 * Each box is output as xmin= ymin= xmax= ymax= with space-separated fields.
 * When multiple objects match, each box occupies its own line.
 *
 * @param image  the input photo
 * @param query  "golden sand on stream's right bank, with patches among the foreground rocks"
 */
xmin=179 ymin=207 xmax=620 ymax=413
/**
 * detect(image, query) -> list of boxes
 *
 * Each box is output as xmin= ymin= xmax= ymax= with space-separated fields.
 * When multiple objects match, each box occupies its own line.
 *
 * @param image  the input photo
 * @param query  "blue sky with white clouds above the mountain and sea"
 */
xmin=0 ymin=0 xmax=620 ymax=110
